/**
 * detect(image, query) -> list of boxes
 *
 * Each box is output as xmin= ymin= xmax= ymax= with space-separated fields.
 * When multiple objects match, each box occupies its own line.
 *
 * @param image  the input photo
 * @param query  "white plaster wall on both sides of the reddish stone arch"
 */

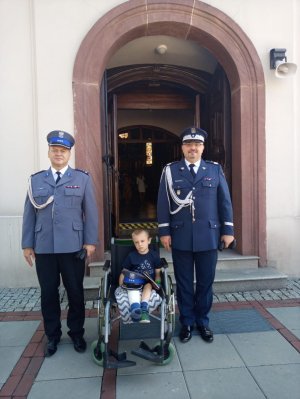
xmin=0 ymin=0 xmax=300 ymax=286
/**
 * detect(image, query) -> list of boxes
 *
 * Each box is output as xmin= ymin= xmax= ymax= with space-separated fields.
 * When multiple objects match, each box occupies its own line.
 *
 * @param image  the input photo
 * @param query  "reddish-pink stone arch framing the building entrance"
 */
xmin=73 ymin=0 xmax=266 ymax=266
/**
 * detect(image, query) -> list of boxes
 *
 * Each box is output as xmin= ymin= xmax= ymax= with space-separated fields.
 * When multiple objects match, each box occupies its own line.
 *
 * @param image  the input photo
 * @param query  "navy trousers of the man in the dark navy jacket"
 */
xmin=172 ymin=249 xmax=218 ymax=327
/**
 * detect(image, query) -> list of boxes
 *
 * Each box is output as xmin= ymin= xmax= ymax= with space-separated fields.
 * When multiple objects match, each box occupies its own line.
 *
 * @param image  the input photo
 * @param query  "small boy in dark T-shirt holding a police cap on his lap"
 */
xmin=119 ymin=229 xmax=161 ymax=323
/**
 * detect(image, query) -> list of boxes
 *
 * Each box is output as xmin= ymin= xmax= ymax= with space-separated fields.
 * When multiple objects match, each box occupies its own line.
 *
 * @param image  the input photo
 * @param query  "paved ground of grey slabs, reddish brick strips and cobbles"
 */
xmin=0 ymin=279 xmax=300 ymax=399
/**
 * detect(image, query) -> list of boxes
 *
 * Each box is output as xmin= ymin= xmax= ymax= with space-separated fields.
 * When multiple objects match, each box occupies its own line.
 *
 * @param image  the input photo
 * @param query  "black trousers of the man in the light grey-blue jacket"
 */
xmin=35 ymin=252 xmax=85 ymax=339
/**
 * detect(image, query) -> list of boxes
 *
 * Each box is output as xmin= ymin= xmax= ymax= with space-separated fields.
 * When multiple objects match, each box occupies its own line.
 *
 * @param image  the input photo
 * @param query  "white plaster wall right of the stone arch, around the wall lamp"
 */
xmin=206 ymin=0 xmax=300 ymax=276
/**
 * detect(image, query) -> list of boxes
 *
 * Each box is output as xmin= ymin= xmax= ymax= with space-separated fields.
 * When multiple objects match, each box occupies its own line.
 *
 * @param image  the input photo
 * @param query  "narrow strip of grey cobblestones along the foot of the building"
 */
xmin=0 ymin=278 xmax=300 ymax=312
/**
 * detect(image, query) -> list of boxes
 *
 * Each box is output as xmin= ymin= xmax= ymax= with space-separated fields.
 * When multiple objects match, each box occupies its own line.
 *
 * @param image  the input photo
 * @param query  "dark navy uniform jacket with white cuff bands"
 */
xmin=157 ymin=159 xmax=234 ymax=252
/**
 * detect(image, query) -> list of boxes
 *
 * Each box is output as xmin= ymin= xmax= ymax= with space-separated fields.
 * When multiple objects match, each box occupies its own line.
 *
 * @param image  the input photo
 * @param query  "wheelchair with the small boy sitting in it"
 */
xmin=91 ymin=230 xmax=175 ymax=368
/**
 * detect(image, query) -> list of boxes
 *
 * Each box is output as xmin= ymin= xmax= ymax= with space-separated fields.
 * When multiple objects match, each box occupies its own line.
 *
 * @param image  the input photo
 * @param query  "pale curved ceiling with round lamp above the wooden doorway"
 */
xmin=107 ymin=36 xmax=217 ymax=74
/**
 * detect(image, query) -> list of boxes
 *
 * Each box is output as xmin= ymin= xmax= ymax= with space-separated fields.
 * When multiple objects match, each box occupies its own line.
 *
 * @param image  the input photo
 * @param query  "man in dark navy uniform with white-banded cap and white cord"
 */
xmin=157 ymin=127 xmax=234 ymax=342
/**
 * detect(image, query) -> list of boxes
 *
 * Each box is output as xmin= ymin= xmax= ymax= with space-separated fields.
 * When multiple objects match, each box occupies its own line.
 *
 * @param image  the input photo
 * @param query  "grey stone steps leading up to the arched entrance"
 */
xmin=84 ymin=249 xmax=287 ymax=300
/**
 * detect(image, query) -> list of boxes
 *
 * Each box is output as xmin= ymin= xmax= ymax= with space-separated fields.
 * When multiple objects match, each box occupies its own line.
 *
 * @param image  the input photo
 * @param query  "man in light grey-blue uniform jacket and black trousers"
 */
xmin=22 ymin=130 xmax=98 ymax=357
